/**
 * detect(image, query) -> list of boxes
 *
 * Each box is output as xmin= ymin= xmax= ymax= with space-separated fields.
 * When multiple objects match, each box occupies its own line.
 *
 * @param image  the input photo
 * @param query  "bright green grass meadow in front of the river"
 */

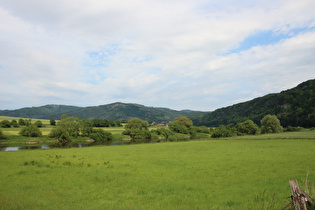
xmin=0 ymin=139 xmax=315 ymax=209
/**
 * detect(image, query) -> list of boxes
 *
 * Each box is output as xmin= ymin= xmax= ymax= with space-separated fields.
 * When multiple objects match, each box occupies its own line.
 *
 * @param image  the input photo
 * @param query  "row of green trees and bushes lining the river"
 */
xmin=0 ymin=115 xmax=308 ymax=144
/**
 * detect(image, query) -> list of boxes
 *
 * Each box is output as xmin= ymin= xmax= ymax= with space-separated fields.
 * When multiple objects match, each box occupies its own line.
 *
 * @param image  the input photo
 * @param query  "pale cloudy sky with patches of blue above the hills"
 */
xmin=0 ymin=0 xmax=315 ymax=111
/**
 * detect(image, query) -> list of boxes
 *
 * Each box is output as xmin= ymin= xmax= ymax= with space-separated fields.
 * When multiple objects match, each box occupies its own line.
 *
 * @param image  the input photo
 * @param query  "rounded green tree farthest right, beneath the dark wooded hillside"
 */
xmin=261 ymin=115 xmax=283 ymax=133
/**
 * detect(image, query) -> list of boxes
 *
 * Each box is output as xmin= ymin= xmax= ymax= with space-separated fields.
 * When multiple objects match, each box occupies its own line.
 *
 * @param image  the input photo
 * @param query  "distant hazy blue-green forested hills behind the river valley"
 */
xmin=0 ymin=102 xmax=207 ymax=123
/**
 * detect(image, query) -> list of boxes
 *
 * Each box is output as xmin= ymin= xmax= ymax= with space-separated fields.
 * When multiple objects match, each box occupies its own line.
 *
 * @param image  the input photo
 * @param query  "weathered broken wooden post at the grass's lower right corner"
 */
xmin=289 ymin=180 xmax=314 ymax=210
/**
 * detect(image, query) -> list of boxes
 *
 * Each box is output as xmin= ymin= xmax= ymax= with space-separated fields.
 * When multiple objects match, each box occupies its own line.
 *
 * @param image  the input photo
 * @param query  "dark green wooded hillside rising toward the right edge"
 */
xmin=193 ymin=80 xmax=315 ymax=127
